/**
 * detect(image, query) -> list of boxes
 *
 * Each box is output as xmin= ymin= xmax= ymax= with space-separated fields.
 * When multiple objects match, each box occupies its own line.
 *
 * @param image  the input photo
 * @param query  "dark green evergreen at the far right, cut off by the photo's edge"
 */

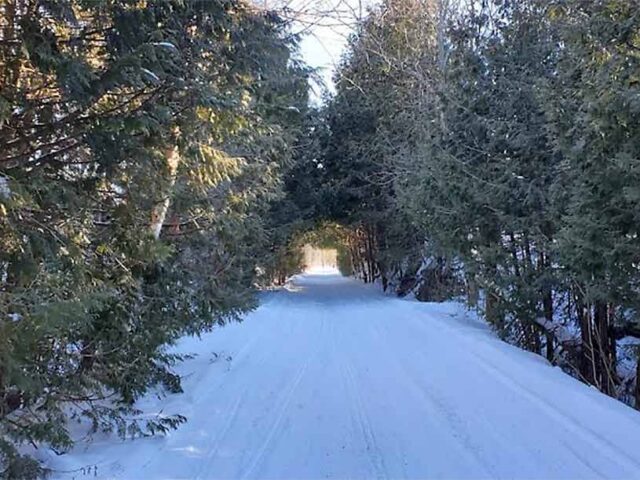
xmin=545 ymin=0 xmax=640 ymax=396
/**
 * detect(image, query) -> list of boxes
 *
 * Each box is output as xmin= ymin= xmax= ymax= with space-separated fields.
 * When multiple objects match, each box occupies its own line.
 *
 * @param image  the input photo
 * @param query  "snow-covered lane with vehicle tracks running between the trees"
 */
xmin=48 ymin=274 xmax=640 ymax=479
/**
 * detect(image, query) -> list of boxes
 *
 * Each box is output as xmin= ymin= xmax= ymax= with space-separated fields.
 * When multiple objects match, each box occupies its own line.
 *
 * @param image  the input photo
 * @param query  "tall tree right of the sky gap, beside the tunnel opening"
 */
xmin=308 ymin=2 xmax=433 ymax=289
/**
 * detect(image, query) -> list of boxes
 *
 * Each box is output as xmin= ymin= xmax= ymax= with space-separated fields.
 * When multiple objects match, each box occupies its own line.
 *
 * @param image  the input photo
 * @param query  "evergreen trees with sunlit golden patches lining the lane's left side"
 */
xmin=0 ymin=0 xmax=309 ymax=478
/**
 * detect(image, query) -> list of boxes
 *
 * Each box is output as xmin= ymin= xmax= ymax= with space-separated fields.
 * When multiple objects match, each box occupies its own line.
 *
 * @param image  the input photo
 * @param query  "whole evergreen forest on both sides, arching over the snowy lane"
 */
xmin=0 ymin=0 xmax=640 ymax=478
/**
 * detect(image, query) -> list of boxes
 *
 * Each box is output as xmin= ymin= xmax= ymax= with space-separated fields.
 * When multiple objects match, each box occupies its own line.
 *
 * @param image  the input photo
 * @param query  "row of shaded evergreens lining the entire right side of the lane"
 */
xmin=322 ymin=0 xmax=640 ymax=406
